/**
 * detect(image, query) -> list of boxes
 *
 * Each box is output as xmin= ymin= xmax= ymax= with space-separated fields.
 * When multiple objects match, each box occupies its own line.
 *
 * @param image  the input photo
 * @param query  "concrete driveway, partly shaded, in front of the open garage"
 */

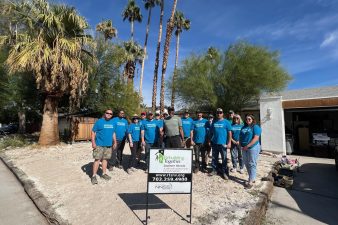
xmin=266 ymin=156 xmax=338 ymax=225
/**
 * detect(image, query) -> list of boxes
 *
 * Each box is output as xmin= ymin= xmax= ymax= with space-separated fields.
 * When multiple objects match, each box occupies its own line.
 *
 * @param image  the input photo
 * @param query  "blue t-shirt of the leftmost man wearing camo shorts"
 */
xmin=92 ymin=118 xmax=115 ymax=147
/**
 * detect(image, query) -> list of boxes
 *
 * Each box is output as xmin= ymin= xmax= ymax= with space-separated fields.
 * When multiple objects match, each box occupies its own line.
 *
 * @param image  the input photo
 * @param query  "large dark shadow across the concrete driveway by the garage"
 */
xmin=284 ymin=163 xmax=338 ymax=224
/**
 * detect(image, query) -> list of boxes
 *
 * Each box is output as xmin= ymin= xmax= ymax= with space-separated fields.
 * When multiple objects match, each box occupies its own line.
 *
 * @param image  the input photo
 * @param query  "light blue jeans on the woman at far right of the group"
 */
xmin=243 ymin=144 xmax=261 ymax=182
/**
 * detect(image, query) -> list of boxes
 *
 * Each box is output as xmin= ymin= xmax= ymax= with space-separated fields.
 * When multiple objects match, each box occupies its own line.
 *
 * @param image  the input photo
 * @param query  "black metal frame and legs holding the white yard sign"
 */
xmin=145 ymin=148 xmax=193 ymax=225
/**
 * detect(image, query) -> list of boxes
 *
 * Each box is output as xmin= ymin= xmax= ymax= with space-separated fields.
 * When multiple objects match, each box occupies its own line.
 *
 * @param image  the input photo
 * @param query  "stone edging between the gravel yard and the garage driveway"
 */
xmin=244 ymin=172 xmax=273 ymax=225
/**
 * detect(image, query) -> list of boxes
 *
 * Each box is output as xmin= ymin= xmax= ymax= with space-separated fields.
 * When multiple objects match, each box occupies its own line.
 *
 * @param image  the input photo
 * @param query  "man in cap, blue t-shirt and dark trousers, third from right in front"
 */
xmin=210 ymin=108 xmax=231 ymax=180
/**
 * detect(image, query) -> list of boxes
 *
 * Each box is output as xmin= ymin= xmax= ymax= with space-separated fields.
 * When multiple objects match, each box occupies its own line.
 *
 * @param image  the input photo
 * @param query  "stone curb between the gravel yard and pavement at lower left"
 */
xmin=0 ymin=153 xmax=70 ymax=225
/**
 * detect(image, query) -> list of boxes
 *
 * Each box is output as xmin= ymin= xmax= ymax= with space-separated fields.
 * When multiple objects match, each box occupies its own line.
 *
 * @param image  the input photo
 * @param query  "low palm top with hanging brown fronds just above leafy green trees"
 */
xmin=123 ymin=41 xmax=144 ymax=83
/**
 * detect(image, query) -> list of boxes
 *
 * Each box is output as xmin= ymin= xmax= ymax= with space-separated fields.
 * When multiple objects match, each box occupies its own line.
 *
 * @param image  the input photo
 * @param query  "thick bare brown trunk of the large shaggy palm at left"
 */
xmin=39 ymin=96 xmax=60 ymax=145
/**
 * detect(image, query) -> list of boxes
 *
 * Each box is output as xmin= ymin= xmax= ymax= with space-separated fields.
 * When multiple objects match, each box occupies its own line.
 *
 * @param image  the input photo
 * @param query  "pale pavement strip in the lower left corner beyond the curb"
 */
xmin=0 ymin=160 xmax=48 ymax=225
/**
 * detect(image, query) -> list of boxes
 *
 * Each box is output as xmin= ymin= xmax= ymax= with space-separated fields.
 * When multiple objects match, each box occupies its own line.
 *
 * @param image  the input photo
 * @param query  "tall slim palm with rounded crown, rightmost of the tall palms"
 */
xmin=171 ymin=11 xmax=190 ymax=107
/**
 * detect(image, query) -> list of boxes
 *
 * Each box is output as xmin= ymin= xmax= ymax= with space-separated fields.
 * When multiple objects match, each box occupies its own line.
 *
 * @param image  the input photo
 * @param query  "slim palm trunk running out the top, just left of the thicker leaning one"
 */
xmin=151 ymin=0 xmax=164 ymax=111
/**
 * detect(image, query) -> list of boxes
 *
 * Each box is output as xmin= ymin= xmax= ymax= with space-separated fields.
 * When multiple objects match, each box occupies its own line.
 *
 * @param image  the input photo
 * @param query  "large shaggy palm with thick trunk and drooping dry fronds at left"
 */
xmin=0 ymin=0 xmax=91 ymax=145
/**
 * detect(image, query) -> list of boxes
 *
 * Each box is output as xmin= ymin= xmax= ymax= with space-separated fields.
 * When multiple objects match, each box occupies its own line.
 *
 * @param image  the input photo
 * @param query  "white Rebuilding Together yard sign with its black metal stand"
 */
xmin=146 ymin=148 xmax=192 ymax=224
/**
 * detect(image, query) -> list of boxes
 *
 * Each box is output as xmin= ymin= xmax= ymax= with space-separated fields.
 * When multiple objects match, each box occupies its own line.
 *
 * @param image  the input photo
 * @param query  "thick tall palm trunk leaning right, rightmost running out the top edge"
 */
xmin=160 ymin=0 xmax=177 ymax=112
